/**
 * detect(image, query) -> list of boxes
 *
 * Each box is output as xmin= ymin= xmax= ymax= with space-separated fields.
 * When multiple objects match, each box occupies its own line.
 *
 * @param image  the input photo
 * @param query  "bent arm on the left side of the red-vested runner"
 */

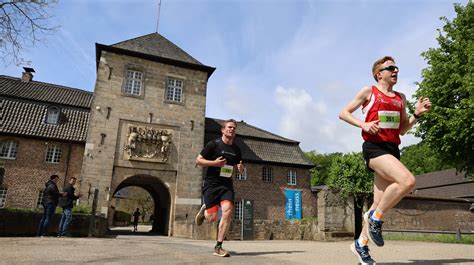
xmin=339 ymin=86 xmax=379 ymax=134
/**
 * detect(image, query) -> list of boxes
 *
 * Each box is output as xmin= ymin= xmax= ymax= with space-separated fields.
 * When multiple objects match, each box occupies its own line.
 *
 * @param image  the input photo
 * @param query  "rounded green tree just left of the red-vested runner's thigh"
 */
xmin=327 ymin=152 xmax=374 ymax=198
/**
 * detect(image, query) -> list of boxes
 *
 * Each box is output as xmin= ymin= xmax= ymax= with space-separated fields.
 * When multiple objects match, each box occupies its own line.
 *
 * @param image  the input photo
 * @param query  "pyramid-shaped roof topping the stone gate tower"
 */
xmin=96 ymin=32 xmax=216 ymax=78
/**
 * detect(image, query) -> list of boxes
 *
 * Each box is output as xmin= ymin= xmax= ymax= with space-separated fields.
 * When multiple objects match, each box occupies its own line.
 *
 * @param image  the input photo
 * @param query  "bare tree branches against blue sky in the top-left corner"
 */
xmin=0 ymin=0 xmax=57 ymax=65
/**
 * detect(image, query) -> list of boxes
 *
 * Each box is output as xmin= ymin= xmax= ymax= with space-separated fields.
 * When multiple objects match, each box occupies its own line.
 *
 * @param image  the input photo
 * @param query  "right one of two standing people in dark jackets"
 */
xmin=58 ymin=177 xmax=82 ymax=237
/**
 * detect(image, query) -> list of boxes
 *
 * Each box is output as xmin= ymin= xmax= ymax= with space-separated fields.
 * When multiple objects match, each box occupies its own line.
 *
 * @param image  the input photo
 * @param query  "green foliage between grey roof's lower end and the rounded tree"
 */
xmin=305 ymin=150 xmax=342 ymax=186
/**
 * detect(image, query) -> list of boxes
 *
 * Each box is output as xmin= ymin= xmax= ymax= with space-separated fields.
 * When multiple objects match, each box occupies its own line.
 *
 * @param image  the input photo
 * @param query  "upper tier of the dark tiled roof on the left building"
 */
xmin=0 ymin=75 xmax=93 ymax=108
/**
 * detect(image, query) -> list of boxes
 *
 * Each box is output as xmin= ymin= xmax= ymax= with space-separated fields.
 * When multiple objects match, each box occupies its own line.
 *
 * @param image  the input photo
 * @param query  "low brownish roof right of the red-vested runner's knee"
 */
xmin=413 ymin=168 xmax=474 ymax=198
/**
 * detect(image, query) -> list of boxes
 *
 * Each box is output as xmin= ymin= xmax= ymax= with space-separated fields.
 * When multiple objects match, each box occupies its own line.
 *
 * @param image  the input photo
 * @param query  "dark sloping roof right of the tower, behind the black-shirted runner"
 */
xmin=205 ymin=118 xmax=314 ymax=168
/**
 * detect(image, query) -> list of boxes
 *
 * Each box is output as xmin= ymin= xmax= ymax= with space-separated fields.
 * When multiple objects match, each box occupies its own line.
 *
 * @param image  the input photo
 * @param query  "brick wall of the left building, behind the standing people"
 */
xmin=0 ymin=136 xmax=84 ymax=208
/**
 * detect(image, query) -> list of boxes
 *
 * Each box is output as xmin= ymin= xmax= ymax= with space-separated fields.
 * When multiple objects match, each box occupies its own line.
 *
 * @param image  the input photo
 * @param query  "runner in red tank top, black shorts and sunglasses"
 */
xmin=339 ymin=56 xmax=431 ymax=264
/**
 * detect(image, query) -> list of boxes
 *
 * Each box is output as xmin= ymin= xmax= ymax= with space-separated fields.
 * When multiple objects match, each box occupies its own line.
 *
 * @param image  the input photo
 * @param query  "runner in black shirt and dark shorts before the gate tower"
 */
xmin=195 ymin=119 xmax=244 ymax=257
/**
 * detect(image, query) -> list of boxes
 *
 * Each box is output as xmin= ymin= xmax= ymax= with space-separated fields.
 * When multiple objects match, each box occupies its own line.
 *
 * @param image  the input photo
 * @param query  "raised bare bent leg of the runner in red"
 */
xmin=370 ymin=155 xmax=415 ymax=212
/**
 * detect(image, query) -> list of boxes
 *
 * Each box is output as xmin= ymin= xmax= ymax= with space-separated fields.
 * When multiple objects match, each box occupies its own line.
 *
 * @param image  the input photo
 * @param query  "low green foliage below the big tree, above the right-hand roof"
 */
xmin=400 ymin=142 xmax=453 ymax=176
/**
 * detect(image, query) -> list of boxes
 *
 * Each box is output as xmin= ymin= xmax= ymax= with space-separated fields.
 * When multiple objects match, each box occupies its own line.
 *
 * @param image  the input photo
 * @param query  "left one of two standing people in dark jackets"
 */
xmin=36 ymin=175 xmax=65 ymax=236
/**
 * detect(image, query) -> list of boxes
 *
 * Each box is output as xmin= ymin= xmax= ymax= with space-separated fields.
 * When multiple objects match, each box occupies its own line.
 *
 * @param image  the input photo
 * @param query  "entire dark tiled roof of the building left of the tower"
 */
xmin=0 ymin=76 xmax=93 ymax=142
